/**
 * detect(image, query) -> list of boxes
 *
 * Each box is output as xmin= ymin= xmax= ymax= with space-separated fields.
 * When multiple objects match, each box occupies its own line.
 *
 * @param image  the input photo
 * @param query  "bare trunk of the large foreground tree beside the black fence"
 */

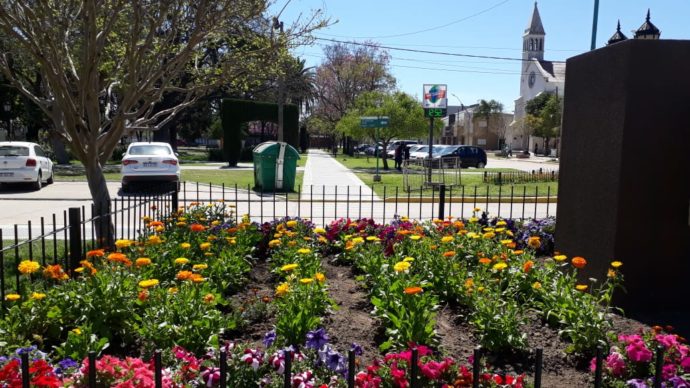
xmin=84 ymin=160 xmax=114 ymax=248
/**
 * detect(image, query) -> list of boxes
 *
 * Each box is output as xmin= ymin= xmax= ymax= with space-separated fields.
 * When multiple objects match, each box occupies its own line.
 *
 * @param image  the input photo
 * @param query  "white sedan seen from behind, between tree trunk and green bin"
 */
xmin=121 ymin=142 xmax=180 ymax=193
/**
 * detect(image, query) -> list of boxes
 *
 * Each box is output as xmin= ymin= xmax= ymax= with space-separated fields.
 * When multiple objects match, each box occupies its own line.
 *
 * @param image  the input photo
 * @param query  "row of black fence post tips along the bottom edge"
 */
xmin=8 ymin=345 xmax=665 ymax=388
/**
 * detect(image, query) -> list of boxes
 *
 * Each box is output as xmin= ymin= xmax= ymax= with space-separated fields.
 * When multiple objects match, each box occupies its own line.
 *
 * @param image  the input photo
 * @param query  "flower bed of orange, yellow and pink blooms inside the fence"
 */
xmin=0 ymin=203 xmax=686 ymax=387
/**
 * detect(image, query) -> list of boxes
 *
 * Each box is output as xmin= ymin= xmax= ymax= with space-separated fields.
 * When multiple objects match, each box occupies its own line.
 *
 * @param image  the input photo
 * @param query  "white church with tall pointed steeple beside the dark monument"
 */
xmin=510 ymin=2 xmax=565 ymax=151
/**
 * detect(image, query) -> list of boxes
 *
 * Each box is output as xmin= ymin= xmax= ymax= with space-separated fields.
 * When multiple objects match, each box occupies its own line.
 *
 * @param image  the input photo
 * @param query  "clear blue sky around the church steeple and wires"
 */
xmin=273 ymin=0 xmax=690 ymax=112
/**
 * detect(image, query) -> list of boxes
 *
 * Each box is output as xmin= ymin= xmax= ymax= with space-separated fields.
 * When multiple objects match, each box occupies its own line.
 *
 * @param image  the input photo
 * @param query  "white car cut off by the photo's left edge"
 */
xmin=0 ymin=141 xmax=53 ymax=190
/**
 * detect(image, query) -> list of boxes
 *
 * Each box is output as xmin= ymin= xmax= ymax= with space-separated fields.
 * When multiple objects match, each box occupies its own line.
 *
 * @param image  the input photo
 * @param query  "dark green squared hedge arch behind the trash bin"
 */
xmin=220 ymin=98 xmax=299 ymax=166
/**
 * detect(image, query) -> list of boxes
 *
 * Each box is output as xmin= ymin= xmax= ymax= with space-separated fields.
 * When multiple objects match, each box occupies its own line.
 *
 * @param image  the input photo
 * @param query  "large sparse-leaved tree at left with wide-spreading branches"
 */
xmin=0 ymin=0 xmax=324 ymax=243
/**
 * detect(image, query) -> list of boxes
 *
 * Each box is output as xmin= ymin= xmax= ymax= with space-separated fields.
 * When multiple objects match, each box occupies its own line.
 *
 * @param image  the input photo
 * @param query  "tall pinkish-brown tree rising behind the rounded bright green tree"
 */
xmin=310 ymin=43 xmax=395 ymax=142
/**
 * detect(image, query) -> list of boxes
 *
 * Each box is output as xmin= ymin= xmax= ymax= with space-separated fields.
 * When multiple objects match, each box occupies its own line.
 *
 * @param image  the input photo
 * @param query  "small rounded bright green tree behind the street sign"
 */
xmin=336 ymin=92 xmax=443 ymax=170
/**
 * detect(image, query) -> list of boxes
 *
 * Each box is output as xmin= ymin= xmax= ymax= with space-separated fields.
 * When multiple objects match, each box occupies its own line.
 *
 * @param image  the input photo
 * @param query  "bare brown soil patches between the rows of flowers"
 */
xmin=227 ymin=259 xmax=646 ymax=387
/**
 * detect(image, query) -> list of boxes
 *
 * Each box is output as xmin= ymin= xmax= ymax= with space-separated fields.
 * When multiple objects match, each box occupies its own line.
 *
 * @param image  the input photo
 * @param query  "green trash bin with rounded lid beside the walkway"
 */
xmin=252 ymin=141 xmax=299 ymax=191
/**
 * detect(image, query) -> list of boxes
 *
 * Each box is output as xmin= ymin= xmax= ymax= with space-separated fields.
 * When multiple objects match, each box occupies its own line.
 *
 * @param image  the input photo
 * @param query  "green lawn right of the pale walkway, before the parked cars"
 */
xmin=356 ymin=170 xmax=558 ymax=198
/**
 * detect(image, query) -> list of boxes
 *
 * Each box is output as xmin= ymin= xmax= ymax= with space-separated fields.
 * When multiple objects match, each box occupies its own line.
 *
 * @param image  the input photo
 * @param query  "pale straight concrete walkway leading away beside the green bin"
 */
xmin=301 ymin=149 xmax=380 ymax=200
